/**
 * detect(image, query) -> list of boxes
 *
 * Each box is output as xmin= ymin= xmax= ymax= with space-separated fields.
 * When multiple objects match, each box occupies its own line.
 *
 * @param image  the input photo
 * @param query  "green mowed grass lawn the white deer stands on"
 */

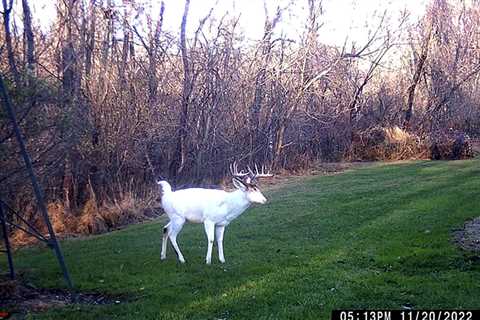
xmin=1 ymin=160 xmax=480 ymax=319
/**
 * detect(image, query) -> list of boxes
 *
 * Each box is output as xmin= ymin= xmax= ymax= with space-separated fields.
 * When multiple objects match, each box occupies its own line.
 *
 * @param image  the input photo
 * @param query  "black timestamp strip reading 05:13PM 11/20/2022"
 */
xmin=331 ymin=310 xmax=480 ymax=320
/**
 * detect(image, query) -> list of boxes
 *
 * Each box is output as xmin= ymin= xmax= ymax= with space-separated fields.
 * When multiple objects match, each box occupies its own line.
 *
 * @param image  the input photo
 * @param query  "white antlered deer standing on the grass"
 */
xmin=157 ymin=163 xmax=272 ymax=264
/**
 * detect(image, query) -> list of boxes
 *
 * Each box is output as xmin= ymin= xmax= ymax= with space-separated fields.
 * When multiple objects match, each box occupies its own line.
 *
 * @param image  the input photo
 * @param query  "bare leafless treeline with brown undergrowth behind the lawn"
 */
xmin=0 ymin=0 xmax=480 ymax=236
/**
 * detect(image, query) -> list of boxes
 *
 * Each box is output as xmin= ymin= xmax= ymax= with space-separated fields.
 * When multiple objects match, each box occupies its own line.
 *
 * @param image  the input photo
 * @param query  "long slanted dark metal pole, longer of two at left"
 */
xmin=0 ymin=76 xmax=73 ymax=288
